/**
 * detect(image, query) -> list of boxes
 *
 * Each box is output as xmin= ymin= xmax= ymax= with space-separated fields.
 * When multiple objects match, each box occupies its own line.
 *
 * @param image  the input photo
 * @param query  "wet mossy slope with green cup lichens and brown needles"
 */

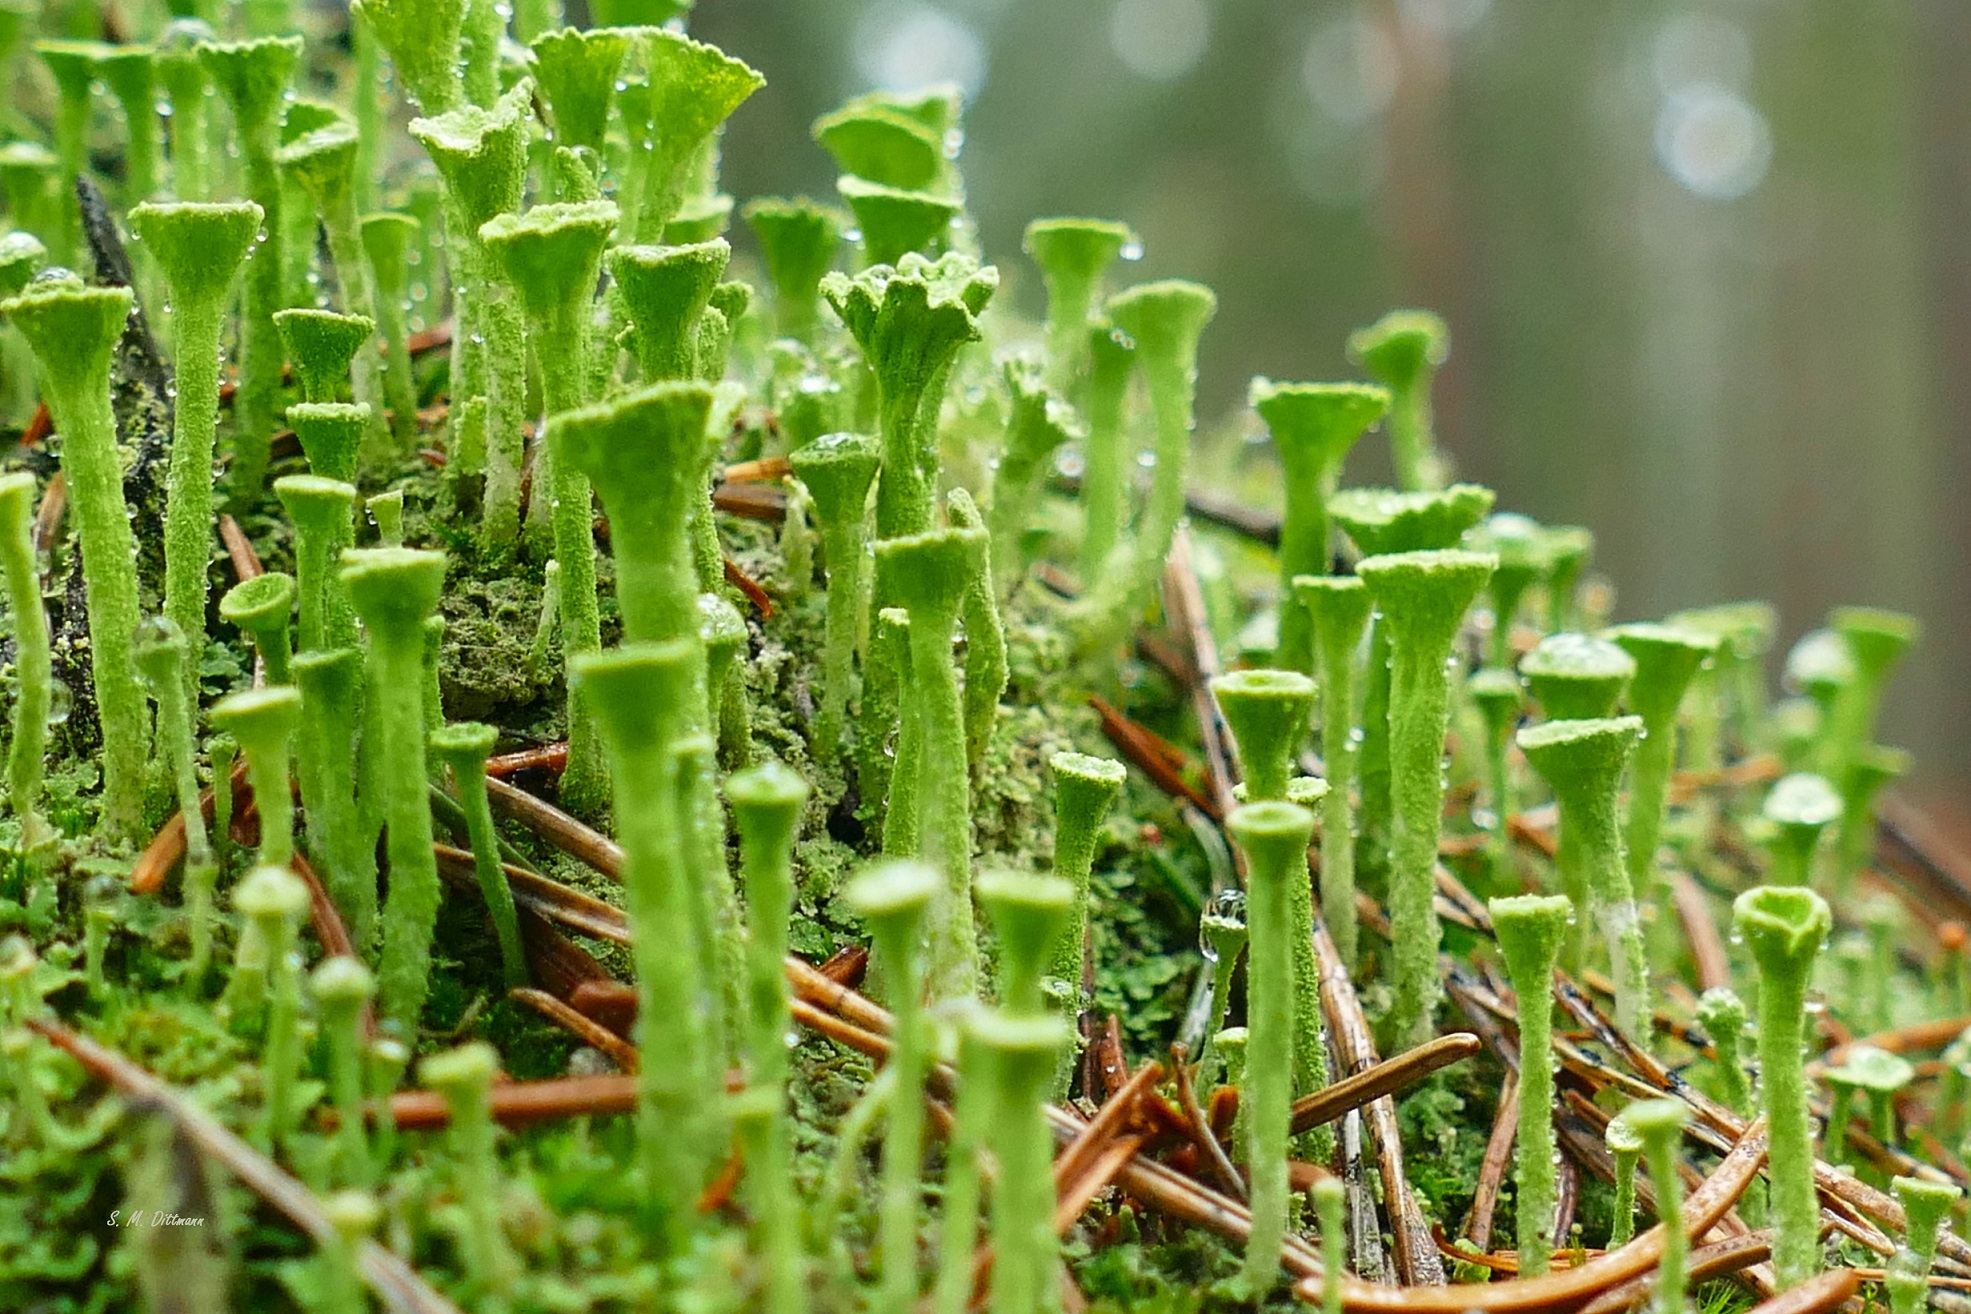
xmin=0 ymin=0 xmax=1971 ymax=1314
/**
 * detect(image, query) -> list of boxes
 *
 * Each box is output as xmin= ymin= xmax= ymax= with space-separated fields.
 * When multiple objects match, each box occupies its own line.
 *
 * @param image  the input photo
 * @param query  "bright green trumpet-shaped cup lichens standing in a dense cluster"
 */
xmin=0 ymin=0 xmax=1965 ymax=1314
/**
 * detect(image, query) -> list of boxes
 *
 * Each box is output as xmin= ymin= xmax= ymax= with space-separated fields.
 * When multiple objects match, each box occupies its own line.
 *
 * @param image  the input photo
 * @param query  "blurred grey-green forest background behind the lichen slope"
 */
xmin=692 ymin=0 xmax=1971 ymax=812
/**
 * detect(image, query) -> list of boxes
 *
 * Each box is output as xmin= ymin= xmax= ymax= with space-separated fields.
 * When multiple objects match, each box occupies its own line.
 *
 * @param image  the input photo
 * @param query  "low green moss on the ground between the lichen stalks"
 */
xmin=0 ymin=395 xmax=1844 ymax=1312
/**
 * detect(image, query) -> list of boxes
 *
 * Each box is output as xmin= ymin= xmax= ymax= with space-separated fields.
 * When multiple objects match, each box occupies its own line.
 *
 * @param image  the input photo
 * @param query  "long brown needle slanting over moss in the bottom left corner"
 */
xmin=26 ymin=1018 xmax=459 ymax=1314
